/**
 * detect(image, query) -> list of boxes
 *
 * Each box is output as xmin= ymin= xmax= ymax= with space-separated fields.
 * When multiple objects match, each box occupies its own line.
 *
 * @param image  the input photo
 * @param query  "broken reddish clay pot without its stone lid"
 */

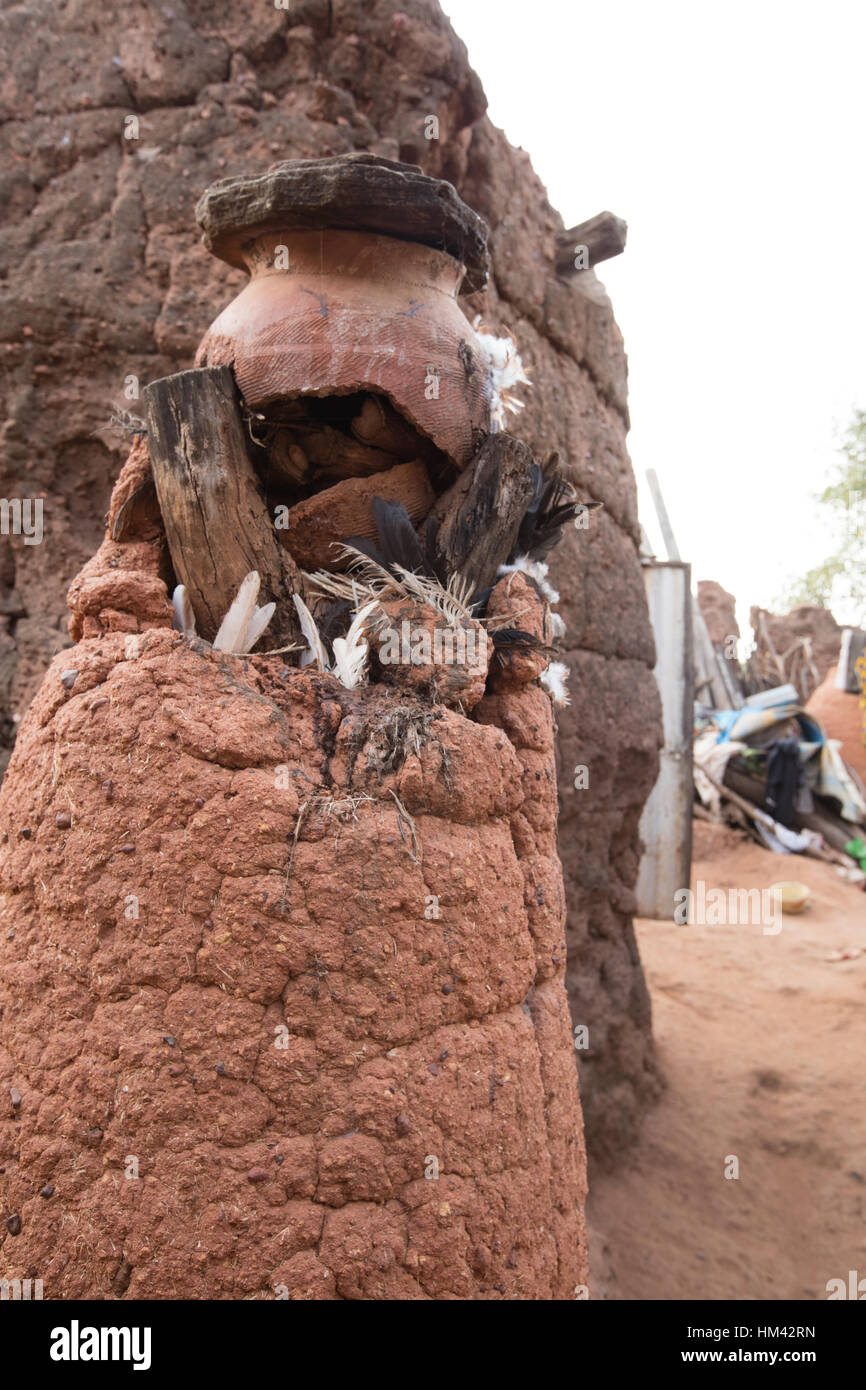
xmin=196 ymin=231 xmax=488 ymax=467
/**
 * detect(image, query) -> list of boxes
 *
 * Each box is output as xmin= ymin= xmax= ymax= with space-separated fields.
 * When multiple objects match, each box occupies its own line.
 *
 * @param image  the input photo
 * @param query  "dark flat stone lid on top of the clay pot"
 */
xmin=196 ymin=154 xmax=489 ymax=293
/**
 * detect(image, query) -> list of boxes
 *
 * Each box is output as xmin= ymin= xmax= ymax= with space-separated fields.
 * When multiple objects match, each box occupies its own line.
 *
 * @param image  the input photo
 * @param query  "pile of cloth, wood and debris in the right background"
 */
xmin=694 ymin=569 xmax=866 ymax=887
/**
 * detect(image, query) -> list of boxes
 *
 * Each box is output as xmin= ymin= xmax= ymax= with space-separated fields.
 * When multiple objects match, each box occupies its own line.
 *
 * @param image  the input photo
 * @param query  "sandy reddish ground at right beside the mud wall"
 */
xmin=589 ymin=823 xmax=866 ymax=1300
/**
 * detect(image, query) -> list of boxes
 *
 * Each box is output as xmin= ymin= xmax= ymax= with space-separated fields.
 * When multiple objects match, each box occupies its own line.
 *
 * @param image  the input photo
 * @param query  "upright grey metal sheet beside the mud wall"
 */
xmin=635 ymin=562 xmax=695 ymax=920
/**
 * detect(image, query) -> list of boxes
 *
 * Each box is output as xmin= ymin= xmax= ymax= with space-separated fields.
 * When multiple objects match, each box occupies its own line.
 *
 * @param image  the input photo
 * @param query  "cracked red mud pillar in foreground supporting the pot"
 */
xmin=0 ymin=528 xmax=587 ymax=1300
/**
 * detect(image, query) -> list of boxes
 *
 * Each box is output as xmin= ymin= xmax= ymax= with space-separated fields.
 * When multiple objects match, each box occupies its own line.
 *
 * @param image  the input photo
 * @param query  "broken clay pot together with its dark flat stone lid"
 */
xmin=196 ymin=154 xmax=489 ymax=467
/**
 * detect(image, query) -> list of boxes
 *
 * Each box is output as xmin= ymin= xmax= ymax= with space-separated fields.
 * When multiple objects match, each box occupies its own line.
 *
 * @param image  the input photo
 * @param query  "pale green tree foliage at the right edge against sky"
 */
xmin=784 ymin=410 xmax=866 ymax=623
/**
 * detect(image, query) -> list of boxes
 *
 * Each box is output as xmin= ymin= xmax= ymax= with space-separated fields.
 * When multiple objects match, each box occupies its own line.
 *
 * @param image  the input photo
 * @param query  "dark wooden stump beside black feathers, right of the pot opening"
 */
xmin=431 ymin=432 xmax=534 ymax=591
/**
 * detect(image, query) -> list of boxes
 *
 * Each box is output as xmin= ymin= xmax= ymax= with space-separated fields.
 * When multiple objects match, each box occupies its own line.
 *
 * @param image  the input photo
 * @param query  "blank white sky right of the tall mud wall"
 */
xmin=442 ymin=0 xmax=866 ymax=627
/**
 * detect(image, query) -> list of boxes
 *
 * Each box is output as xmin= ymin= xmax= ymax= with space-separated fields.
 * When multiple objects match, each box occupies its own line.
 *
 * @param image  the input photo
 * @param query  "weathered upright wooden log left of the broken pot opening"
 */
xmin=143 ymin=367 xmax=297 ymax=645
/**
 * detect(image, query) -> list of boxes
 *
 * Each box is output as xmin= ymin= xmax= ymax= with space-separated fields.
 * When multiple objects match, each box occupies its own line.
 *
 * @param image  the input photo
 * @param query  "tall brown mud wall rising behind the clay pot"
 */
xmin=0 ymin=0 xmax=659 ymax=1158
